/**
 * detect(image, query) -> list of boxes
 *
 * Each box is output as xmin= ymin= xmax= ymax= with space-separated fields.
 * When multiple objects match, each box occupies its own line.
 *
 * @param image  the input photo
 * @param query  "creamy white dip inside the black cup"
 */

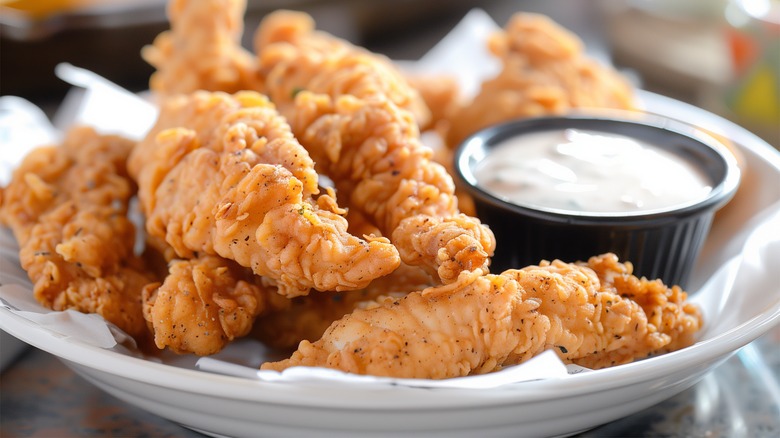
xmin=474 ymin=129 xmax=712 ymax=213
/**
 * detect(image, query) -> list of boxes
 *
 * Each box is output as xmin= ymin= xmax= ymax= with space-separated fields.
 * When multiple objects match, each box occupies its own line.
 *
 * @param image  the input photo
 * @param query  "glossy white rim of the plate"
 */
xmin=0 ymin=90 xmax=780 ymax=411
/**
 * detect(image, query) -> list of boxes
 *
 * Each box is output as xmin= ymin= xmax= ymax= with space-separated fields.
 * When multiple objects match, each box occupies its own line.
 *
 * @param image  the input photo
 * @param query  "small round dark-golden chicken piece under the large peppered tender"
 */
xmin=143 ymin=256 xmax=275 ymax=356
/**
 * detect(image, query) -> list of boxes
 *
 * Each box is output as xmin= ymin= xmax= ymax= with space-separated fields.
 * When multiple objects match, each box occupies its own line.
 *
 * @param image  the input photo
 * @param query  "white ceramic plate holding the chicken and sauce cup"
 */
xmin=0 ymin=93 xmax=780 ymax=437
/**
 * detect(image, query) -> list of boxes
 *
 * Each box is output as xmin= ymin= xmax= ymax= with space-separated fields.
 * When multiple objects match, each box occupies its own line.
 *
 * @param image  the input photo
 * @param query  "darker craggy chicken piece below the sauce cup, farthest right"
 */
xmin=503 ymin=254 xmax=702 ymax=368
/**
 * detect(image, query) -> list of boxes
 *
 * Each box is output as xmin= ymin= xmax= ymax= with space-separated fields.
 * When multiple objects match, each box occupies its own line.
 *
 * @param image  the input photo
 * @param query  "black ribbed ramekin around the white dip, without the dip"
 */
xmin=455 ymin=112 xmax=740 ymax=287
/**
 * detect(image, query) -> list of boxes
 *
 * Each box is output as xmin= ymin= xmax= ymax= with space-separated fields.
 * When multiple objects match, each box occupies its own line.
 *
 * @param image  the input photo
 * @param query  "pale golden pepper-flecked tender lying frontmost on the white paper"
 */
xmin=262 ymin=269 xmax=549 ymax=379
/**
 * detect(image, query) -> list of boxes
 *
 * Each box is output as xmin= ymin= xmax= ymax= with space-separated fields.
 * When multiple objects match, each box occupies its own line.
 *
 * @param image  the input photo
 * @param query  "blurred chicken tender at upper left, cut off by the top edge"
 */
xmin=141 ymin=0 xmax=257 ymax=96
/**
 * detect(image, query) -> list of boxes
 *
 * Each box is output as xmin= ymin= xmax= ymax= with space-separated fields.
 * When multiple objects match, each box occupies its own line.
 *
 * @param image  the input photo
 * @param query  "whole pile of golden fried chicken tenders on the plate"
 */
xmin=0 ymin=0 xmax=702 ymax=379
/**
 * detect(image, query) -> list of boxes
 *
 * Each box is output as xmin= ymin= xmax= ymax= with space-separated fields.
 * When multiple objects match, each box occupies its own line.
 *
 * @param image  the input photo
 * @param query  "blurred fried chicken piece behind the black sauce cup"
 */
xmin=446 ymin=13 xmax=635 ymax=148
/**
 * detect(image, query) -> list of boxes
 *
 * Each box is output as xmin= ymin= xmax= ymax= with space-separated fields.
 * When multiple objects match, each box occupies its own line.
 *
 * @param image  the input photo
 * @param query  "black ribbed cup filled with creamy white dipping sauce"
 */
xmin=455 ymin=111 xmax=740 ymax=287
